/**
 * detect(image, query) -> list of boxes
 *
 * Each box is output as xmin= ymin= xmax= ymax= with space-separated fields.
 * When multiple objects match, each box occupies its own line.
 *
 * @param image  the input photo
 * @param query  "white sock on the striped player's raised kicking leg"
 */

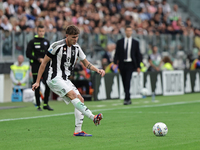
xmin=71 ymin=98 xmax=94 ymax=120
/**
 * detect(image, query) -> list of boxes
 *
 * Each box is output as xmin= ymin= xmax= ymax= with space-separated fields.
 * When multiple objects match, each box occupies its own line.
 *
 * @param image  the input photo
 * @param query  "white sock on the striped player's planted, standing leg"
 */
xmin=74 ymin=108 xmax=84 ymax=133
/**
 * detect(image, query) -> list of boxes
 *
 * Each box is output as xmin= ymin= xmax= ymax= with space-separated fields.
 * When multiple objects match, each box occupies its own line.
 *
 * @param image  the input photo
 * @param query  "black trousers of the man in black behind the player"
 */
xmin=33 ymin=72 xmax=50 ymax=106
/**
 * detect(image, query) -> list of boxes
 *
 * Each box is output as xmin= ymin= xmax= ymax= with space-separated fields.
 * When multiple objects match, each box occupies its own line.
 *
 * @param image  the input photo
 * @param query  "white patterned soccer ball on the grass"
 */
xmin=153 ymin=122 xmax=168 ymax=136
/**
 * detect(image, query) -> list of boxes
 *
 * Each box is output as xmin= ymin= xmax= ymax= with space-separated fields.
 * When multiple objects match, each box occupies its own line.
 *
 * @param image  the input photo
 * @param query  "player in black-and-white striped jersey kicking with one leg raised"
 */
xmin=32 ymin=25 xmax=105 ymax=136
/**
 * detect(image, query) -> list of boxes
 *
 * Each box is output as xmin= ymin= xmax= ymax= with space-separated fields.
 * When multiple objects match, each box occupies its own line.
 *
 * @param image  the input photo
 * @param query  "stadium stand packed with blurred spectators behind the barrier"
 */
xmin=0 ymin=0 xmax=200 ymax=71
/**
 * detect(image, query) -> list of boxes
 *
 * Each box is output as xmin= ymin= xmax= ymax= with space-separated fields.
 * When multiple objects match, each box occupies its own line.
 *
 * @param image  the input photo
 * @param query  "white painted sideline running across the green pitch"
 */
xmin=0 ymin=100 xmax=200 ymax=122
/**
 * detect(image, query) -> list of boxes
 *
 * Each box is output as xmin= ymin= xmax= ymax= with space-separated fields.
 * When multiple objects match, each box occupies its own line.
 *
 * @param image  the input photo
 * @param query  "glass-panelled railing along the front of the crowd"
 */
xmin=0 ymin=31 xmax=193 ymax=62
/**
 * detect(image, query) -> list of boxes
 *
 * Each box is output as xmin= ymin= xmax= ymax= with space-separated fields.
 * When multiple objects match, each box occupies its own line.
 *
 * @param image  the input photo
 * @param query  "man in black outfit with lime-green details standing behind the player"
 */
xmin=26 ymin=25 xmax=53 ymax=111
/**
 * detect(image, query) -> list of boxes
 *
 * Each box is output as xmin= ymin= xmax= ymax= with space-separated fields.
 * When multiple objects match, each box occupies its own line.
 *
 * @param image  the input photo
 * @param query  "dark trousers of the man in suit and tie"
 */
xmin=120 ymin=62 xmax=134 ymax=101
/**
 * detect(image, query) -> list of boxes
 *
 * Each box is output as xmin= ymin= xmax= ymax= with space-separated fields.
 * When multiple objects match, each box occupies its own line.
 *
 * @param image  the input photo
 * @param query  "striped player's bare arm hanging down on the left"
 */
xmin=32 ymin=55 xmax=51 ymax=91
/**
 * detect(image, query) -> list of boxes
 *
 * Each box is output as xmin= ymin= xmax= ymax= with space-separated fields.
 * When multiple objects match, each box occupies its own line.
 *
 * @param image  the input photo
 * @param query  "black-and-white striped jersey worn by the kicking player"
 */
xmin=47 ymin=39 xmax=86 ymax=80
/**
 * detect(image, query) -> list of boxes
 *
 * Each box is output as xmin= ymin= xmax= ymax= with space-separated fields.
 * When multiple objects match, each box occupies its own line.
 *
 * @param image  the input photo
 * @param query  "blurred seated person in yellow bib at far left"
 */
xmin=10 ymin=55 xmax=29 ymax=89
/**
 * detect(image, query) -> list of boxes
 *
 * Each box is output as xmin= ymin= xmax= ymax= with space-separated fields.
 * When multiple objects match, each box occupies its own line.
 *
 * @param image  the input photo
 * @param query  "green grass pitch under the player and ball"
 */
xmin=0 ymin=94 xmax=200 ymax=150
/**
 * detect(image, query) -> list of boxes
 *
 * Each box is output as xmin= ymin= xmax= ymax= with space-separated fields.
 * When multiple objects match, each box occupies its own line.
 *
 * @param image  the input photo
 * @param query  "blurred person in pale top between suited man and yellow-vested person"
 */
xmin=148 ymin=46 xmax=162 ymax=71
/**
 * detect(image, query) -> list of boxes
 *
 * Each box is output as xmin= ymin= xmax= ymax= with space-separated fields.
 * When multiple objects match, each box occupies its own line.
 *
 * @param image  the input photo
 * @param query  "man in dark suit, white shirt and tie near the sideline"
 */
xmin=114 ymin=26 xmax=141 ymax=105
